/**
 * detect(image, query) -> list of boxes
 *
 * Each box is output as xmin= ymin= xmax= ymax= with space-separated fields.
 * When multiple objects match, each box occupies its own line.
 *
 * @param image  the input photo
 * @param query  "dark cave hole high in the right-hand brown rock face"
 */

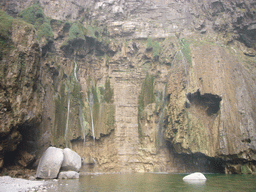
xmin=185 ymin=89 xmax=222 ymax=116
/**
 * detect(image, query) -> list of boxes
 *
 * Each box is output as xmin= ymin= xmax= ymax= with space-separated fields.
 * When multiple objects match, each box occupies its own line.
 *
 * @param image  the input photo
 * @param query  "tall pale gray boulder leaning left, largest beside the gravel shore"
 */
xmin=36 ymin=147 xmax=64 ymax=179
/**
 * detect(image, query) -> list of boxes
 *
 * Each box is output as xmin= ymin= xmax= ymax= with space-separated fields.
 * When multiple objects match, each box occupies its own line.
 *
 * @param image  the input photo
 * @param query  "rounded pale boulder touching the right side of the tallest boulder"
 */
xmin=61 ymin=148 xmax=82 ymax=172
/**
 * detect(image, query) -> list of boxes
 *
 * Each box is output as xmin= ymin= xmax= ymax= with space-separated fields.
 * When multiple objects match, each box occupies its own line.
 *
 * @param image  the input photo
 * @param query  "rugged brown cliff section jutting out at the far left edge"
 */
xmin=0 ymin=11 xmax=42 ymax=167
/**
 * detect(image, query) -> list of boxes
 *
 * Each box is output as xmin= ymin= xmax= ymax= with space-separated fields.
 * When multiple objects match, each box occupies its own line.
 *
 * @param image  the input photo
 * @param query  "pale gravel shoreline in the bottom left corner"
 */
xmin=0 ymin=176 xmax=51 ymax=192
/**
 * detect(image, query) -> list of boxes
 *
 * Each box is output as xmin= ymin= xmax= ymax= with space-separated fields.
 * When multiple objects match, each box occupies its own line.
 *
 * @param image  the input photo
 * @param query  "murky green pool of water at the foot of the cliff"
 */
xmin=48 ymin=173 xmax=256 ymax=192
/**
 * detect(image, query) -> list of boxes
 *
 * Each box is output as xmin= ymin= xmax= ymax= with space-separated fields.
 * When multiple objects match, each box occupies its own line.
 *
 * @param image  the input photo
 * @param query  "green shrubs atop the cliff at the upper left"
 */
xmin=19 ymin=4 xmax=53 ymax=41
